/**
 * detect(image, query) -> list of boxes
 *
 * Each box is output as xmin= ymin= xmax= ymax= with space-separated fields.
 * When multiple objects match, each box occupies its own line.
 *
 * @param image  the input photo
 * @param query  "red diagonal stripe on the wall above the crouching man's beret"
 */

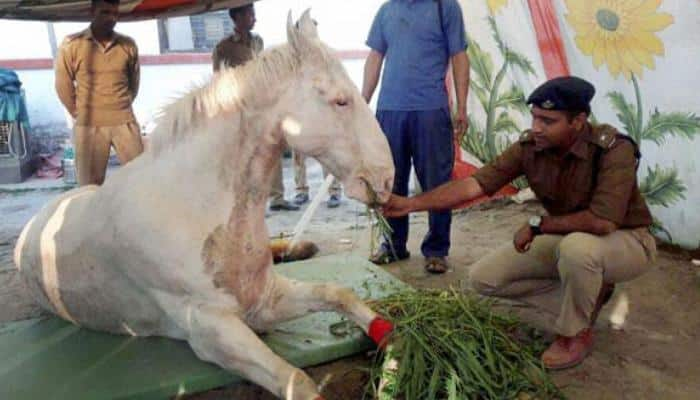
xmin=528 ymin=0 xmax=570 ymax=79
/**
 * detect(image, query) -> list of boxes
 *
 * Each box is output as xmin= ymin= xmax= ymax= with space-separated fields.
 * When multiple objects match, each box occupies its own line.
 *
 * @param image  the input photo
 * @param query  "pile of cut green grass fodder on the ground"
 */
xmin=366 ymin=289 xmax=564 ymax=400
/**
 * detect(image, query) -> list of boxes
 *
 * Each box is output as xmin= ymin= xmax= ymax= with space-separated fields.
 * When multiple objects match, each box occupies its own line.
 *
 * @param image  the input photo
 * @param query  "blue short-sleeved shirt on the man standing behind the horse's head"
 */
xmin=367 ymin=0 xmax=467 ymax=111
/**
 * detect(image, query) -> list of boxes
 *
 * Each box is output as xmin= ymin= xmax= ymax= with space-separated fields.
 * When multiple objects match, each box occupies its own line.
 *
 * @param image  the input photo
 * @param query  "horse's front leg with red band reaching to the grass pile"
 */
xmin=250 ymin=274 xmax=393 ymax=345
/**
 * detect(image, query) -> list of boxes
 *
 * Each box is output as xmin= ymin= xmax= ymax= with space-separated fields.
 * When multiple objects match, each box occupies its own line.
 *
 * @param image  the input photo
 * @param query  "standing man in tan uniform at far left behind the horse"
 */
xmin=55 ymin=0 xmax=143 ymax=186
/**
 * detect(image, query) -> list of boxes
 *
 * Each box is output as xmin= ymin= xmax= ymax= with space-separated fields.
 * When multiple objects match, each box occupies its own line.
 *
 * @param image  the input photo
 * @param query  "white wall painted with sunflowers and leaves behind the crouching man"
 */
xmin=460 ymin=0 xmax=700 ymax=248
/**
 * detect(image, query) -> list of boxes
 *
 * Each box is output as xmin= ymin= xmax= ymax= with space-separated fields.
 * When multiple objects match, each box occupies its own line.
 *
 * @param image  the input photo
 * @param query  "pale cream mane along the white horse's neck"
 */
xmin=149 ymin=38 xmax=333 ymax=154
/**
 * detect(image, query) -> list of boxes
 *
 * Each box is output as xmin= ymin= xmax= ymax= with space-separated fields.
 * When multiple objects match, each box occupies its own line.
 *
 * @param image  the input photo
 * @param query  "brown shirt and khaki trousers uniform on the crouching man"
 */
xmin=470 ymin=125 xmax=656 ymax=336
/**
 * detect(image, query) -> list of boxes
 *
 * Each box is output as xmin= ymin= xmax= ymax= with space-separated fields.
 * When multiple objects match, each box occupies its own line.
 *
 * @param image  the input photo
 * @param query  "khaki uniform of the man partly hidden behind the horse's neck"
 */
xmin=211 ymin=31 xmax=284 ymax=205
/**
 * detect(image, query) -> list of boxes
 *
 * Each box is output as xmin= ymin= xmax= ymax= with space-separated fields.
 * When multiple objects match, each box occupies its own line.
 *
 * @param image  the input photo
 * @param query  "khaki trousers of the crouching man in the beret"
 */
xmin=469 ymin=228 xmax=656 ymax=336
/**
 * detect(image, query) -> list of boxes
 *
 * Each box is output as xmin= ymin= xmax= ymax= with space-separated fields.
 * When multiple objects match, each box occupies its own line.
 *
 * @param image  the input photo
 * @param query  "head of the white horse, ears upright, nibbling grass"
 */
xmin=278 ymin=11 xmax=394 ymax=203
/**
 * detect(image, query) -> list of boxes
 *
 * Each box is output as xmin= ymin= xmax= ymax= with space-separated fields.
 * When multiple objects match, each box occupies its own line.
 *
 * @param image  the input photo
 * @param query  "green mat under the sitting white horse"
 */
xmin=0 ymin=255 xmax=405 ymax=400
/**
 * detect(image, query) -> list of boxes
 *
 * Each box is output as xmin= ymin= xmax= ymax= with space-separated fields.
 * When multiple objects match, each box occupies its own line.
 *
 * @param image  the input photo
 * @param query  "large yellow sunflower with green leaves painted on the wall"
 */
xmin=564 ymin=0 xmax=700 ymax=241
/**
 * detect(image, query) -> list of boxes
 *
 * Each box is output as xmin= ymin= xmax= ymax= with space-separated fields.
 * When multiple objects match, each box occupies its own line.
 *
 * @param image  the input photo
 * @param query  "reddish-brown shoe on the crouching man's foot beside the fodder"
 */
xmin=542 ymin=328 xmax=593 ymax=370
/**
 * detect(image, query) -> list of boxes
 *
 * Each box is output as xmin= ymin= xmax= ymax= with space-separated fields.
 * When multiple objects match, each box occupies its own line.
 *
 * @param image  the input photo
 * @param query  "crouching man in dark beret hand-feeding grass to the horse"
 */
xmin=384 ymin=77 xmax=656 ymax=369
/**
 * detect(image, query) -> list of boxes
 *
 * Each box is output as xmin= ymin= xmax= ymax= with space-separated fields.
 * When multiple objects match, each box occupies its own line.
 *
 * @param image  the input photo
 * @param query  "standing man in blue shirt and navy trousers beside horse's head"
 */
xmin=362 ymin=0 xmax=469 ymax=273
